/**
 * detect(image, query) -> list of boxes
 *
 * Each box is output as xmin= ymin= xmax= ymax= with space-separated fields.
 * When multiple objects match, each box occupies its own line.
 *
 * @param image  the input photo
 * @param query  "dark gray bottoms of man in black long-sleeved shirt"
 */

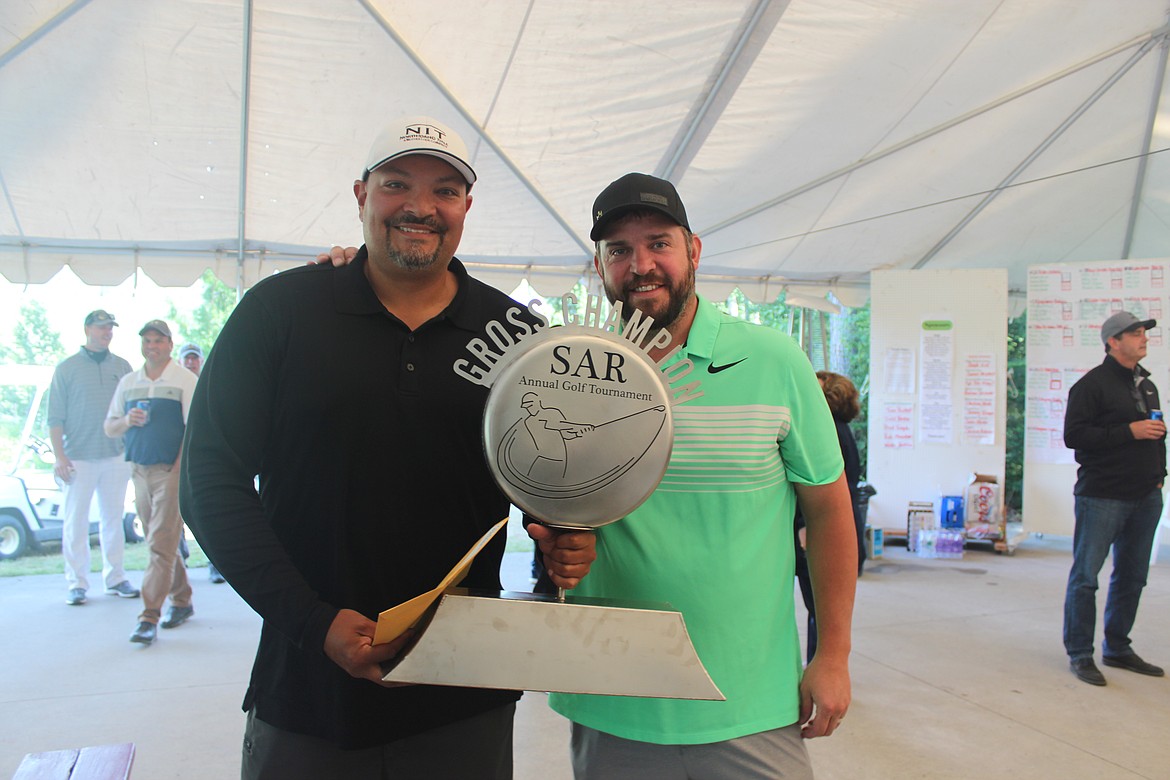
xmin=240 ymin=704 xmax=516 ymax=780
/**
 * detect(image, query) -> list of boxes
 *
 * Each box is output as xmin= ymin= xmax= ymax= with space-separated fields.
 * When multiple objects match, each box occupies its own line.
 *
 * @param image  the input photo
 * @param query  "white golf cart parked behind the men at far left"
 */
xmin=0 ymin=365 xmax=142 ymax=560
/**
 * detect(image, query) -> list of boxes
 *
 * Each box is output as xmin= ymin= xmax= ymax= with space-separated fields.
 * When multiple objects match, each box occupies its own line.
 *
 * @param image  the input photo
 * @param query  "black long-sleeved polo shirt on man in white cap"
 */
xmin=181 ymin=247 xmax=532 ymax=747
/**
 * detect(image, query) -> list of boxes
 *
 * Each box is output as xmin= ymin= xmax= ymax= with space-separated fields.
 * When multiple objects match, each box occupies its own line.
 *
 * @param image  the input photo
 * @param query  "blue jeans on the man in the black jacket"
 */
xmin=1065 ymin=489 xmax=1162 ymax=661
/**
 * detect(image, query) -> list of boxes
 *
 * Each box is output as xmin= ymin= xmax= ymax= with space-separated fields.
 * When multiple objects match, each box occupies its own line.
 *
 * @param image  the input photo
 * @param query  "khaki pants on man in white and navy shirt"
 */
xmin=131 ymin=463 xmax=191 ymax=623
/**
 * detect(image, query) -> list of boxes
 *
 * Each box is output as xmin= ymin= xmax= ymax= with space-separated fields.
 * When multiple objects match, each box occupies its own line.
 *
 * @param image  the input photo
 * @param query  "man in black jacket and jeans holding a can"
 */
xmin=1065 ymin=311 xmax=1166 ymax=685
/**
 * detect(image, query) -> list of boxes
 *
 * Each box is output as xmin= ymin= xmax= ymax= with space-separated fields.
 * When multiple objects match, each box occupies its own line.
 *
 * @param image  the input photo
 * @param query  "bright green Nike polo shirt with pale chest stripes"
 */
xmin=550 ymin=298 xmax=842 ymax=744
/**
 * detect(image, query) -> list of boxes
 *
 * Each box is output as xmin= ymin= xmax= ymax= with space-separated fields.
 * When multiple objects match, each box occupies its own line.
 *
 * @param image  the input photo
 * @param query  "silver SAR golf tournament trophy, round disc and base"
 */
xmin=379 ymin=302 xmax=723 ymax=700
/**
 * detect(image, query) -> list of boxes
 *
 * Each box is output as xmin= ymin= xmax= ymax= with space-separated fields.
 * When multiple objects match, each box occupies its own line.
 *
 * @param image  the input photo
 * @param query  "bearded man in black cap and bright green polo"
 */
xmin=550 ymin=173 xmax=856 ymax=780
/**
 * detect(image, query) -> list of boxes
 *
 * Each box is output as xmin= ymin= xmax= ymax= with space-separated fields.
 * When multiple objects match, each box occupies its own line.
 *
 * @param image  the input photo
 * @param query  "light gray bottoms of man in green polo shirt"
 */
xmin=572 ymin=723 xmax=812 ymax=780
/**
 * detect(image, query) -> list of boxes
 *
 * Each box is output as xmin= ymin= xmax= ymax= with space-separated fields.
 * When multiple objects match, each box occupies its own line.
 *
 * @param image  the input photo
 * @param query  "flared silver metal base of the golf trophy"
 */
xmin=383 ymin=588 xmax=724 ymax=702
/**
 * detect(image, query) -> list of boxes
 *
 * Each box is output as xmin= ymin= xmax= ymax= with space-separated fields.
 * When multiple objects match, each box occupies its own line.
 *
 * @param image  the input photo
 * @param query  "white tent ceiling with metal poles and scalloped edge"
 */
xmin=0 ymin=0 xmax=1170 ymax=303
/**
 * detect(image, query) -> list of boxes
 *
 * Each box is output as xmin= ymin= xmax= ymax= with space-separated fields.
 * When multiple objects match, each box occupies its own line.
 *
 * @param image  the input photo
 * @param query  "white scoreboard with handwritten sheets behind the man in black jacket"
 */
xmin=1024 ymin=258 xmax=1170 ymax=536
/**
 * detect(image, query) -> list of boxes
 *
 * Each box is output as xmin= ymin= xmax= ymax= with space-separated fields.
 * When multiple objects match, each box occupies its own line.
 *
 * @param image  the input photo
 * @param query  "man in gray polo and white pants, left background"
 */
xmin=49 ymin=309 xmax=138 ymax=606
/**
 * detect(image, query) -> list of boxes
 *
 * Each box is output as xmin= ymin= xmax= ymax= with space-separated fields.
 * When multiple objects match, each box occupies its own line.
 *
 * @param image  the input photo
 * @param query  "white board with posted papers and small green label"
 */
xmin=866 ymin=269 xmax=1007 ymax=529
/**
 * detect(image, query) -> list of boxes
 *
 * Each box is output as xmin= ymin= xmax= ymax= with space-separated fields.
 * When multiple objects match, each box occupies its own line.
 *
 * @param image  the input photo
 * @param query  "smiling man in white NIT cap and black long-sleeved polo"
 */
xmin=181 ymin=118 xmax=594 ymax=779
